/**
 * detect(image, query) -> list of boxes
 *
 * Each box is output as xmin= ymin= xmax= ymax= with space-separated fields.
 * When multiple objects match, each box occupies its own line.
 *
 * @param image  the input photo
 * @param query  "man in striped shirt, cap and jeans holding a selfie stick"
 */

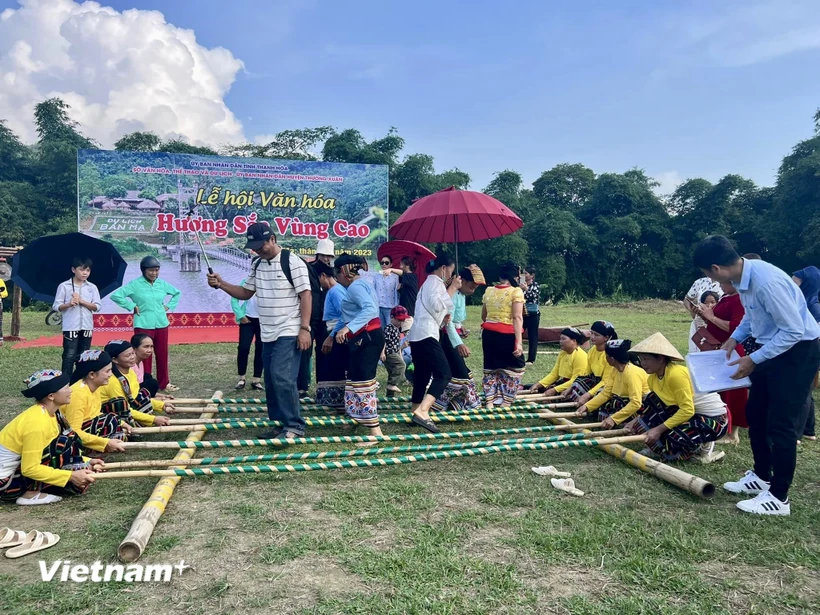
xmin=208 ymin=222 xmax=312 ymax=438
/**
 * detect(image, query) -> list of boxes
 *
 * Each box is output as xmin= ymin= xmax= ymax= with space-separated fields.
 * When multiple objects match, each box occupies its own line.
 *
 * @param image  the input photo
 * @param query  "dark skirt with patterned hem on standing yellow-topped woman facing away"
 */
xmin=481 ymin=329 xmax=524 ymax=406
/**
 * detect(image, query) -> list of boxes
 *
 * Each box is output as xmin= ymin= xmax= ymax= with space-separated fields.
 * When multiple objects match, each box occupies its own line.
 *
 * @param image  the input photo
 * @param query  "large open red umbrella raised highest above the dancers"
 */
xmin=390 ymin=186 xmax=524 ymax=258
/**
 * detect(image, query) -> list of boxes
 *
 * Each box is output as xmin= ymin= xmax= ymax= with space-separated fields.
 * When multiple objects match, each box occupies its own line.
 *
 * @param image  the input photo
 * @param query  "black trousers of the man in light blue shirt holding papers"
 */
xmin=746 ymin=339 xmax=820 ymax=500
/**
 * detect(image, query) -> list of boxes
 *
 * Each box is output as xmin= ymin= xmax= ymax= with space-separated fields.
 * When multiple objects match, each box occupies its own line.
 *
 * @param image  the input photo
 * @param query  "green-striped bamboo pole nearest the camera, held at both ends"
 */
xmin=96 ymin=435 xmax=643 ymax=480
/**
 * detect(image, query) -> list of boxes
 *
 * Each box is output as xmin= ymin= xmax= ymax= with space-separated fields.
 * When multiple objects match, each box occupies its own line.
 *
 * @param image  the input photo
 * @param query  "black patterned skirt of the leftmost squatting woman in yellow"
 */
xmin=0 ymin=412 xmax=88 ymax=502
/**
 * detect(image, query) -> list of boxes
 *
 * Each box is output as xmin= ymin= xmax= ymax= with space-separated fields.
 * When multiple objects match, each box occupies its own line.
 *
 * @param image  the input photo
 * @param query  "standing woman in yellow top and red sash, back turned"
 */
xmin=481 ymin=262 xmax=524 ymax=408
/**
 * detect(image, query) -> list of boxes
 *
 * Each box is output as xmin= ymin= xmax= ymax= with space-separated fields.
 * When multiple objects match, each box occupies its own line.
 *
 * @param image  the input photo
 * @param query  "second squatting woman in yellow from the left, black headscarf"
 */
xmin=65 ymin=350 xmax=131 ymax=446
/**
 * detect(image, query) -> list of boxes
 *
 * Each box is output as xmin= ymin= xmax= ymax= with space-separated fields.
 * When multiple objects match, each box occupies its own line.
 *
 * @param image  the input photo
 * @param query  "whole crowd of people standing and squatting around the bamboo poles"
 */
xmin=0 ymin=229 xmax=820 ymax=515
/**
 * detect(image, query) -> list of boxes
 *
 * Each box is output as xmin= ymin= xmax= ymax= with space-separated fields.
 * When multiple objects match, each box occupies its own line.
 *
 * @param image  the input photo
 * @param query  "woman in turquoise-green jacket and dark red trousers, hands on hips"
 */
xmin=111 ymin=256 xmax=181 ymax=391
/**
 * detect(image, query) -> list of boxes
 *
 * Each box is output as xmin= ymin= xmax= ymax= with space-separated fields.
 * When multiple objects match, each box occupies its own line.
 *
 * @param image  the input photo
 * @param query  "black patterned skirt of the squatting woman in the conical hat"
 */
xmin=635 ymin=391 xmax=729 ymax=461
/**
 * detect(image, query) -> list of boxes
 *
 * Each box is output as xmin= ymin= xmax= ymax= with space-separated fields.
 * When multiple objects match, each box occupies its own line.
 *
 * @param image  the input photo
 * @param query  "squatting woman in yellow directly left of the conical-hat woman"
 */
xmin=576 ymin=340 xmax=649 ymax=429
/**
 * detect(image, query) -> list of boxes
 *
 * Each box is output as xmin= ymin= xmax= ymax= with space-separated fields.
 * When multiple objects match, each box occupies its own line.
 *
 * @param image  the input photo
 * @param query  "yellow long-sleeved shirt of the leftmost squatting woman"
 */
xmin=0 ymin=404 xmax=94 ymax=487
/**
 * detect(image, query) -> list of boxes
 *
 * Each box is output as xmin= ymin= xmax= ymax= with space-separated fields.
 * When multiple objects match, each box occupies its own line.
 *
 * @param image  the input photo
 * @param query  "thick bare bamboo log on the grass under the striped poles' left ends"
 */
xmin=117 ymin=391 xmax=222 ymax=562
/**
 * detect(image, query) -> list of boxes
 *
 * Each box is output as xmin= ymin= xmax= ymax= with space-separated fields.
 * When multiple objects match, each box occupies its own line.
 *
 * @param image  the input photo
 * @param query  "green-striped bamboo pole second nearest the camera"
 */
xmin=105 ymin=429 xmax=629 ymax=471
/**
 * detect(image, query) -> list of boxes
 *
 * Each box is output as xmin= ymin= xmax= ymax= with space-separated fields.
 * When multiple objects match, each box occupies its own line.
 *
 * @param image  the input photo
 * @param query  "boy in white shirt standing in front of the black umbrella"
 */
xmin=52 ymin=257 xmax=102 ymax=376
